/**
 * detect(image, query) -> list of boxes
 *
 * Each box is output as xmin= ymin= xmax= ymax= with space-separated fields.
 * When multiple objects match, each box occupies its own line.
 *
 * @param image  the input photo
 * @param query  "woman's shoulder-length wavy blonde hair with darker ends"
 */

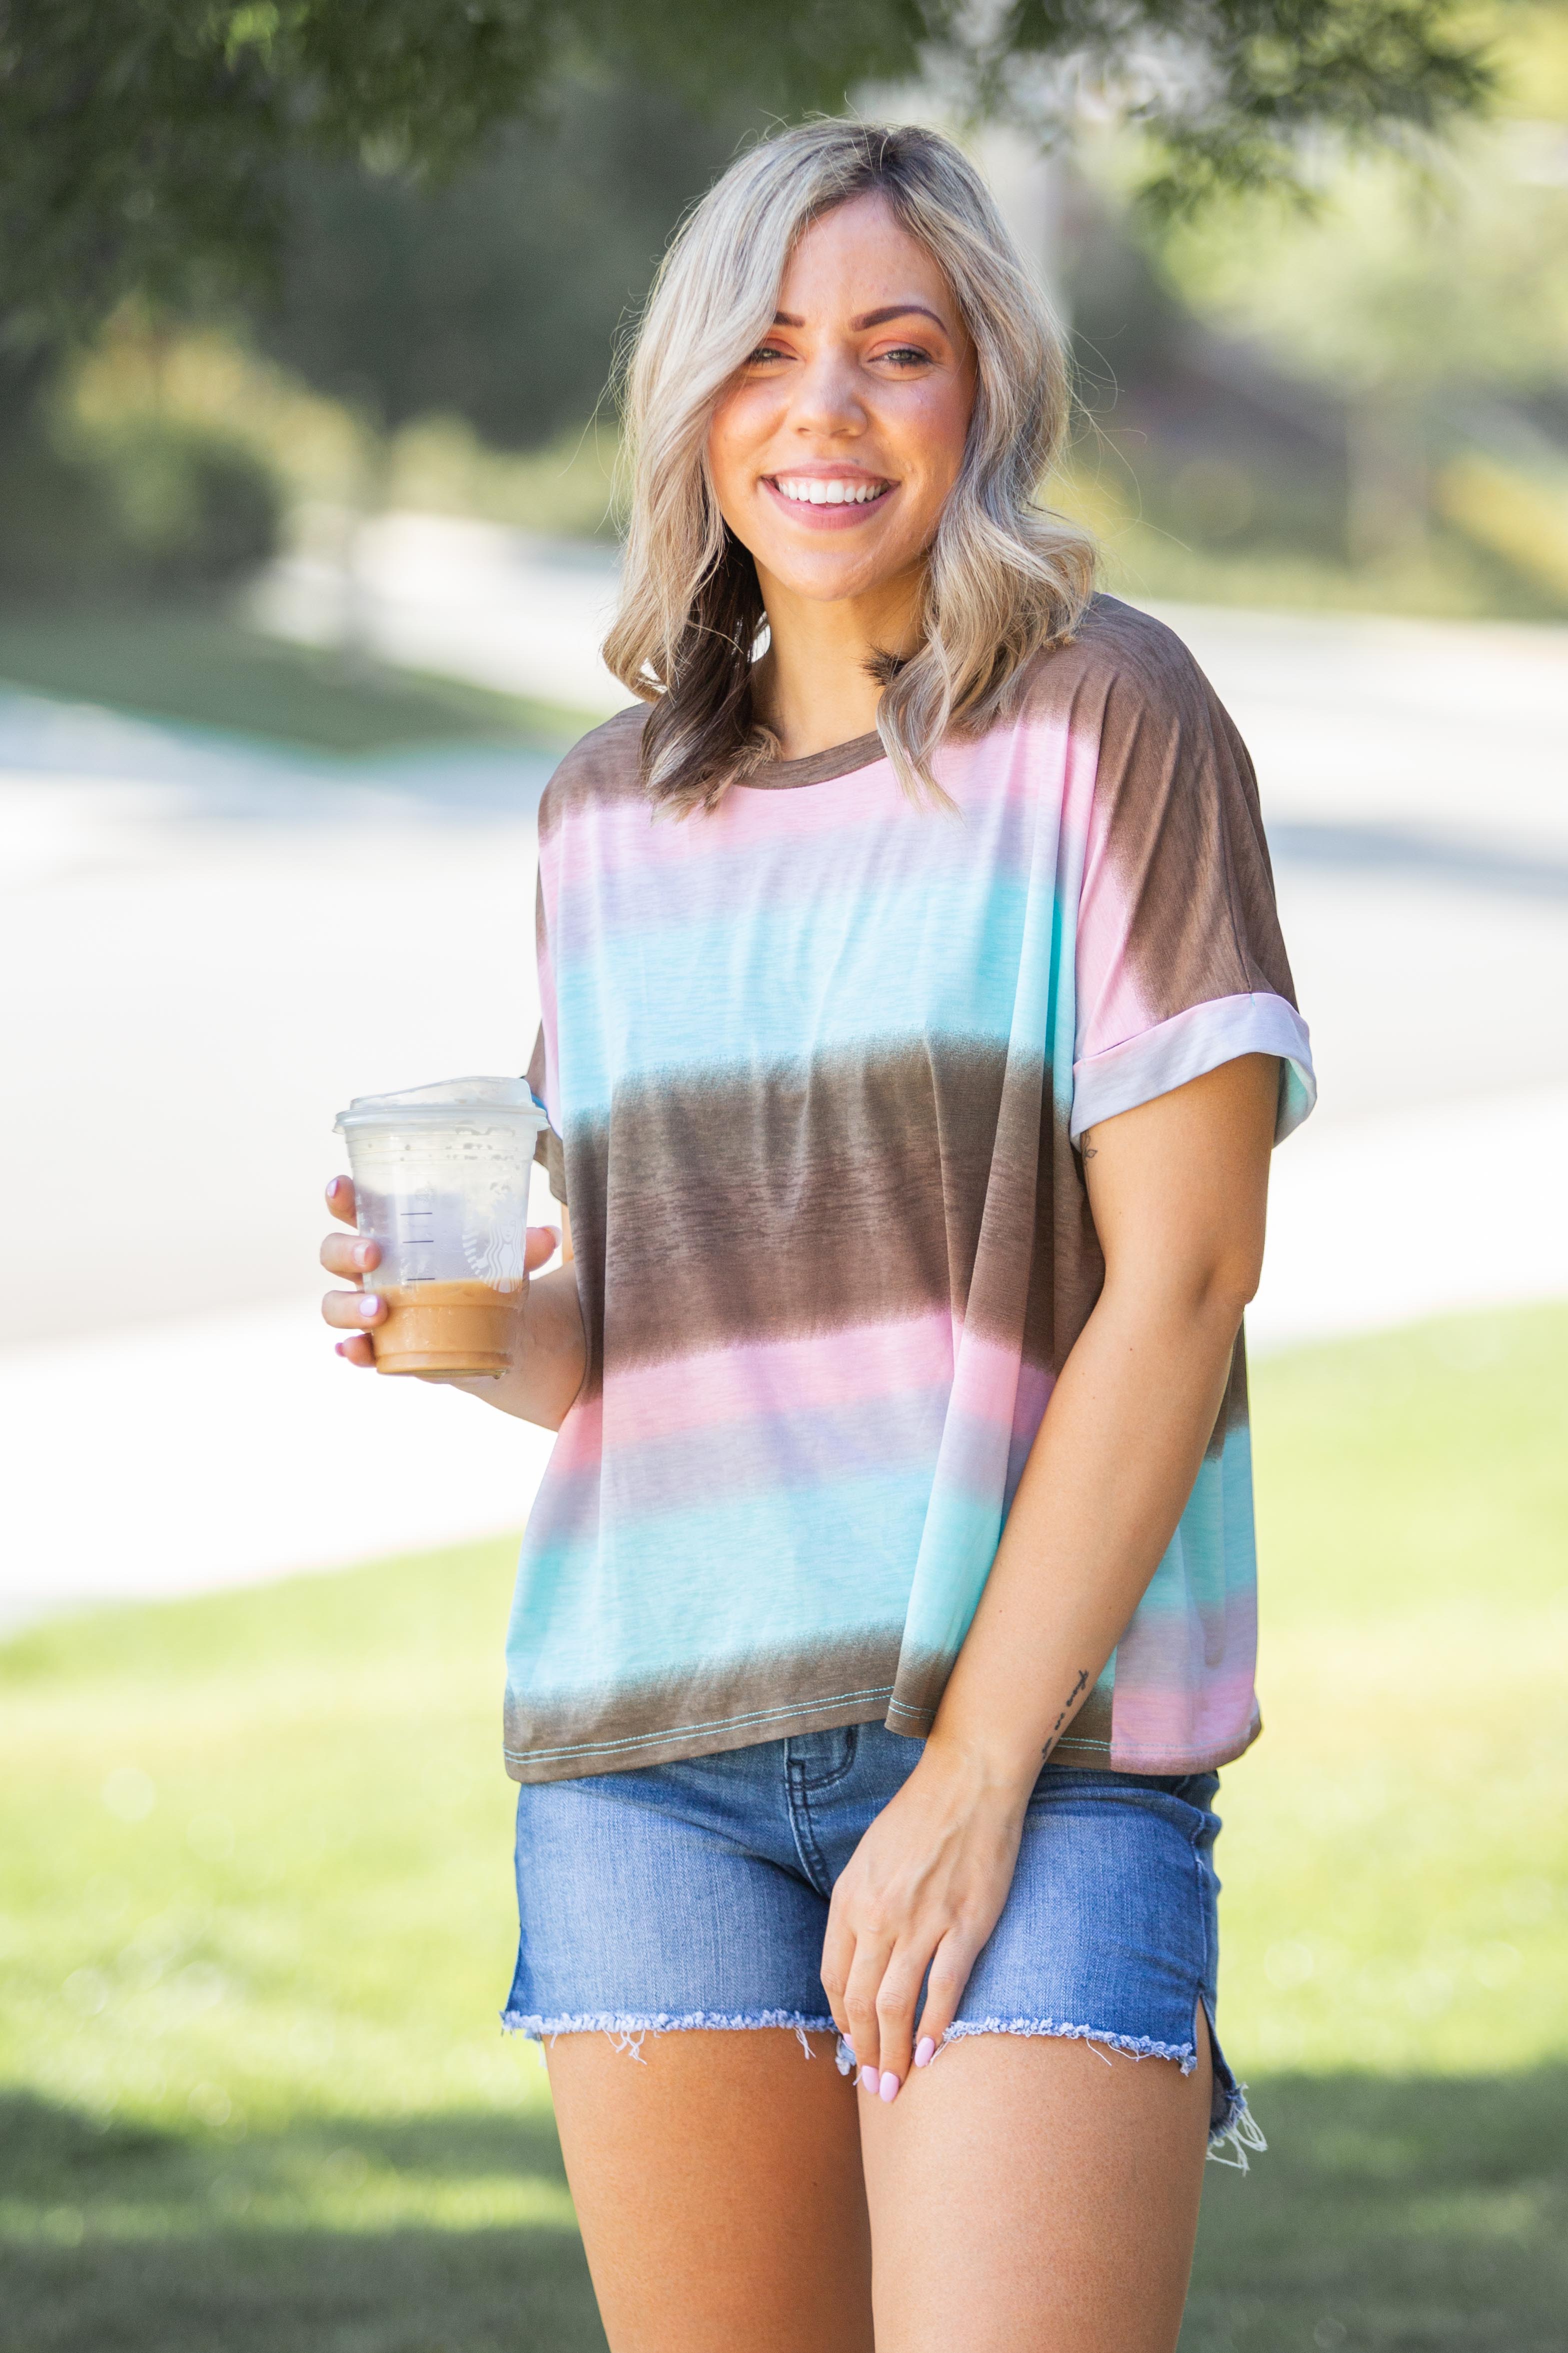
xmin=604 ymin=120 xmax=1096 ymax=814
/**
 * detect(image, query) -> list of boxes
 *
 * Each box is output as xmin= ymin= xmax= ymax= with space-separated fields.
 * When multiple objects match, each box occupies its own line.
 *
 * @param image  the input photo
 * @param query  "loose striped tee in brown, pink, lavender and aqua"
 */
xmin=505 ymin=598 xmax=1314 ymax=1781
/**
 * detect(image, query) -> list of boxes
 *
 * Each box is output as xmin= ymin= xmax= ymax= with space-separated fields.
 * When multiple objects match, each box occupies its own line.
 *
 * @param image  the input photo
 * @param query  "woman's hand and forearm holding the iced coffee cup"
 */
xmin=322 ymin=1176 xmax=588 ymax=1430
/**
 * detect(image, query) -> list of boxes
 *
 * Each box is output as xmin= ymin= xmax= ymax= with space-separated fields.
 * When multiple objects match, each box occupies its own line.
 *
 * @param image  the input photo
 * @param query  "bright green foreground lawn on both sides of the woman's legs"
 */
xmin=0 ymin=1308 xmax=1568 ymax=2353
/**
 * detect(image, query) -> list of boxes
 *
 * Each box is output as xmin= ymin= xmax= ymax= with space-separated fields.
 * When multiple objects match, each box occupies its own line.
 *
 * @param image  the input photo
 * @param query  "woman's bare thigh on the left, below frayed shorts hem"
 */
xmin=545 ymin=2028 xmax=872 ymax=2353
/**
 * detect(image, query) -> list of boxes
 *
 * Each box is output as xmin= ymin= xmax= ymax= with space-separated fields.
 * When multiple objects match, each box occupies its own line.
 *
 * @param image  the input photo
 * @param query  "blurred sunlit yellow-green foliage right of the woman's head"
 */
xmin=1060 ymin=7 xmax=1568 ymax=619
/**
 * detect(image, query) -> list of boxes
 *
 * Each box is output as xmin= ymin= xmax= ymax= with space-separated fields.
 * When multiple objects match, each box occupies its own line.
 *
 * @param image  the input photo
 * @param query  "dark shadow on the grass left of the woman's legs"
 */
xmin=0 ymin=2096 xmax=604 ymax=2353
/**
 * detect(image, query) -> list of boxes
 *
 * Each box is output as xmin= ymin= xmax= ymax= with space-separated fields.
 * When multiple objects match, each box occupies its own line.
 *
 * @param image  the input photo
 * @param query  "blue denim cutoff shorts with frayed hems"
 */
xmin=503 ymin=1724 xmax=1263 ymax=2167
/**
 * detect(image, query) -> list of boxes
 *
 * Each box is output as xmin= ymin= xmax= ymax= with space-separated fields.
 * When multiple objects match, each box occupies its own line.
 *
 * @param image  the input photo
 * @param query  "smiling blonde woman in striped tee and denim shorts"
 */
xmin=322 ymin=122 xmax=1312 ymax=2353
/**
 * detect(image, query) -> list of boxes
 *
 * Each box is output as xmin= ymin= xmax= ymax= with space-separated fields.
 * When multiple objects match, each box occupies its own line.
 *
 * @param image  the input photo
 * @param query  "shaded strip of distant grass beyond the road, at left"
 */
xmin=0 ymin=610 xmax=592 ymax=753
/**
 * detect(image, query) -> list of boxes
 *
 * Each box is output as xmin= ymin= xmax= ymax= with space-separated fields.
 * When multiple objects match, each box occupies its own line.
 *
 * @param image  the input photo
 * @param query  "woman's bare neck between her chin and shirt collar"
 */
xmin=752 ymin=567 xmax=924 ymax=760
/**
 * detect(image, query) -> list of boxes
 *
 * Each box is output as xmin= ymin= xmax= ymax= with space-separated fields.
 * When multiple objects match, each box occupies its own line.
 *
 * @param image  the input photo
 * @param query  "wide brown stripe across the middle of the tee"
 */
xmin=566 ymin=1040 xmax=1103 ymax=1390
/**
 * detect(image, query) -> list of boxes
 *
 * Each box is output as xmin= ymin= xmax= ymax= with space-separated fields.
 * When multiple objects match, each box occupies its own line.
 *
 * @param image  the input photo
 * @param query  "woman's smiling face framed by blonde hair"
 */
xmin=708 ymin=196 xmax=976 ymax=612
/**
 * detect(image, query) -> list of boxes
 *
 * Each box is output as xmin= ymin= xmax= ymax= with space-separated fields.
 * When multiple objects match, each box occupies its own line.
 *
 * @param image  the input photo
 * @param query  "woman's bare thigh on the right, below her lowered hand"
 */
xmin=860 ymin=2019 xmax=1211 ymax=2353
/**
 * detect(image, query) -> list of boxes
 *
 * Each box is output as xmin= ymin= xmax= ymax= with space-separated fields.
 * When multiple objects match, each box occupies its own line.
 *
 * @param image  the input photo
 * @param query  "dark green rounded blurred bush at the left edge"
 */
xmin=0 ymin=392 xmax=282 ymax=607
